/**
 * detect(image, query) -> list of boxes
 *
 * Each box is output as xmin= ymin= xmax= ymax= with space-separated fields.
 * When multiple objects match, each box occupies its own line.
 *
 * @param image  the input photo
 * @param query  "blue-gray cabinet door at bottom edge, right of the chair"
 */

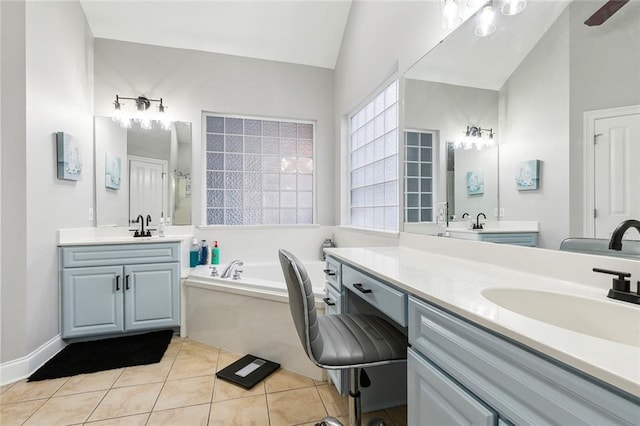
xmin=407 ymin=349 xmax=498 ymax=426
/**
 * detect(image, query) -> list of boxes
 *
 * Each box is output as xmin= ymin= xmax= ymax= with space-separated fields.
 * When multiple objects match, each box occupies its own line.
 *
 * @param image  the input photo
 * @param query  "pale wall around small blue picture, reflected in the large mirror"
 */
xmin=498 ymin=10 xmax=569 ymax=250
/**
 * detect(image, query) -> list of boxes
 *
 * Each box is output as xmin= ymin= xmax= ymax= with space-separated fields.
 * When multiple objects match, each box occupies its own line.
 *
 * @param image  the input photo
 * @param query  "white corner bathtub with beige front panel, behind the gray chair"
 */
xmin=183 ymin=261 xmax=325 ymax=380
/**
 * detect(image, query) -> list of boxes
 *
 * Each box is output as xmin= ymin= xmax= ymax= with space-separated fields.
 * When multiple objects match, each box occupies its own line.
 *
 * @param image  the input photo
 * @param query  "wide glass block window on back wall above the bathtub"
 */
xmin=204 ymin=113 xmax=315 ymax=225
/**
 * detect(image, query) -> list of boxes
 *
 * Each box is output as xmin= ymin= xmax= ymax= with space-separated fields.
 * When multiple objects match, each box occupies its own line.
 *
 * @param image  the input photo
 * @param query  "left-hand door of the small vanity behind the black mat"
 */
xmin=61 ymin=266 xmax=124 ymax=338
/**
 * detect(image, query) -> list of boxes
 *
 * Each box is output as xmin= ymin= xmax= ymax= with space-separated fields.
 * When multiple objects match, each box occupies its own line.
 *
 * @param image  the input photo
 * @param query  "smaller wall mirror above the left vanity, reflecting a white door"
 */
xmin=94 ymin=117 xmax=191 ymax=226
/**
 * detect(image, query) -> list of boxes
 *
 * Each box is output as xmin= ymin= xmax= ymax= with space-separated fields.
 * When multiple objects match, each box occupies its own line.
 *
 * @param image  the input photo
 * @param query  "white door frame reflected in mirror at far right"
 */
xmin=582 ymin=105 xmax=640 ymax=237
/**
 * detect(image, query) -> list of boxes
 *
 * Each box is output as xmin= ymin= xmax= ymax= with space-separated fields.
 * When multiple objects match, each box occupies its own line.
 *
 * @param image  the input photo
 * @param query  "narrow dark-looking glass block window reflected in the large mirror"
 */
xmin=404 ymin=131 xmax=435 ymax=222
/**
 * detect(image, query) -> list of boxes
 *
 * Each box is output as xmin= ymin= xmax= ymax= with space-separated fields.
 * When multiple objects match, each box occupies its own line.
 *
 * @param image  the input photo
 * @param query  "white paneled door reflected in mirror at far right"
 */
xmin=594 ymin=114 xmax=640 ymax=239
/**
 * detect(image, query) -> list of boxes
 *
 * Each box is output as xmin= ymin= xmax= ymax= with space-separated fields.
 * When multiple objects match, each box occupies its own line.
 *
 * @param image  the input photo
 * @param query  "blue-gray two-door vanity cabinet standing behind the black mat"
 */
xmin=60 ymin=243 xmax=180 ymax=338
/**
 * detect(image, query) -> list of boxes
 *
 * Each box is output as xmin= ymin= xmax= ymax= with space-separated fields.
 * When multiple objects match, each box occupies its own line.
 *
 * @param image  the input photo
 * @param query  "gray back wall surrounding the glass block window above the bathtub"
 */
xmin=95 ymin=39 xmax=337 ymax=226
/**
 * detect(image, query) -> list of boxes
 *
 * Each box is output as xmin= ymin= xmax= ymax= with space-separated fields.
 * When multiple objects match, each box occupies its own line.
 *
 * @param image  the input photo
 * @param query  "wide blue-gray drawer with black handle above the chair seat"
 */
xmin=342 ymin=265 xmax=407 ymax=327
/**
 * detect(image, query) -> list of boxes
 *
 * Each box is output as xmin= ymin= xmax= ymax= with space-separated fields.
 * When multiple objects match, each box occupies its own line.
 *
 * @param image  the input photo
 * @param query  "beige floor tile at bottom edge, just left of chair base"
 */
xmin=267 ymin=387 xmax=327 ymax=426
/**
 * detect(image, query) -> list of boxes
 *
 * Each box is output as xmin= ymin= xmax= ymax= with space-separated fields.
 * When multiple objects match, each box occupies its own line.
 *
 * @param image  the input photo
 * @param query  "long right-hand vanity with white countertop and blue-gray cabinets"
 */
xmin=326 ymin=247 xmax=640 ymax=425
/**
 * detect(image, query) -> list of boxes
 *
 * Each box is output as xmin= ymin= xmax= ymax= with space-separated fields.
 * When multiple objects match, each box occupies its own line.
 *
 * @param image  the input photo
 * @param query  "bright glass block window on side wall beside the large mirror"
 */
xmin=349 ymin=80 xmax=398 ymax=231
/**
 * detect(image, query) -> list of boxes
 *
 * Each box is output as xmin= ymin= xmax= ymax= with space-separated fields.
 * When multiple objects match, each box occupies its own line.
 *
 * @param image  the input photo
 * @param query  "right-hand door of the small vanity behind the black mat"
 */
xmin=124 ymin=263 xmax=180 ymax=331
